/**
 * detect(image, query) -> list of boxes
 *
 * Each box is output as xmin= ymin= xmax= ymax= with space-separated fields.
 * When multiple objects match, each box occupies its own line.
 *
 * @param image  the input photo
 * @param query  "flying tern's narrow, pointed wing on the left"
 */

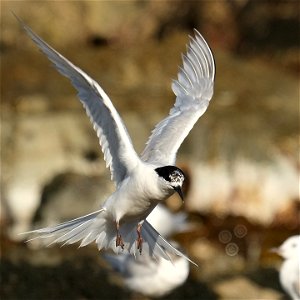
xmin=16 ymin=17 xmax=140 ymax=185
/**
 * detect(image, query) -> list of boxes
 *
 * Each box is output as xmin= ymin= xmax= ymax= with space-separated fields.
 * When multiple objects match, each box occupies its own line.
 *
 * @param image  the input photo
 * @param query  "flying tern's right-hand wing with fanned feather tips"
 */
xmin=141 ymin=30 xmax=215 ymax=165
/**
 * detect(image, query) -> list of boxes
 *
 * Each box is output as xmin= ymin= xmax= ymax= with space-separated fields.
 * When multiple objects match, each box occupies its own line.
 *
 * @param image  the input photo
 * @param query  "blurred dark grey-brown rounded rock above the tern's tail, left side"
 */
xmin=33 ymin=173 xmax=113 ymax=227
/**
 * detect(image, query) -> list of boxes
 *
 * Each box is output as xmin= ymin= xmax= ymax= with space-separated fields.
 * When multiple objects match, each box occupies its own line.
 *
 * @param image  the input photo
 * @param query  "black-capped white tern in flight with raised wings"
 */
xmin=17 ymin=18 xmax=215 ymax=262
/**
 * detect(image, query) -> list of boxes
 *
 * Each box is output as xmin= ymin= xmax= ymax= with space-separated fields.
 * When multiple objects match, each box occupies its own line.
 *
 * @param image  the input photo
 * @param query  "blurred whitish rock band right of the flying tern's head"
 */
xmin=186 ymin=156 xmax=299 ymax=227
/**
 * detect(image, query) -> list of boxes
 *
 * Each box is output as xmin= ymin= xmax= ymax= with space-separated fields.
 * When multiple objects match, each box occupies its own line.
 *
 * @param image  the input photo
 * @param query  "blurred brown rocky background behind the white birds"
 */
xmin=0 ymin=0 xmax=300 ymax=299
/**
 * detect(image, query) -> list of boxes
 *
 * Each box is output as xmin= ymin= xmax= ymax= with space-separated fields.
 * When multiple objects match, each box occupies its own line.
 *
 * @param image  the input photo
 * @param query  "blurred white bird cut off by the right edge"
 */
xmin=271 ymin=235 xmax=300 ymax=300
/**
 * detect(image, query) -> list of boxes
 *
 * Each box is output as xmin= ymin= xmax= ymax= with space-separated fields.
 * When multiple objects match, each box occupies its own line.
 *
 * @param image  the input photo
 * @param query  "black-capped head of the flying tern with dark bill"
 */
xmin=155 ymin=166 xmax=184 ymax=201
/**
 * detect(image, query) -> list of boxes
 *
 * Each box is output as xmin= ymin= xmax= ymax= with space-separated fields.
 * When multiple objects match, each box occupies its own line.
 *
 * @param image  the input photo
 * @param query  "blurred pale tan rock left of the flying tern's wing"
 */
xmin=2 ymin=108 xmax=105 ymax=237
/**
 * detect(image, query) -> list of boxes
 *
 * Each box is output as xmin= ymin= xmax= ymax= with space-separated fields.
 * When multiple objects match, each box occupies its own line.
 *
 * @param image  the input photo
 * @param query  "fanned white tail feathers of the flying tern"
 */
xmin=22 ymin=209 xmax=196 ymax=265
